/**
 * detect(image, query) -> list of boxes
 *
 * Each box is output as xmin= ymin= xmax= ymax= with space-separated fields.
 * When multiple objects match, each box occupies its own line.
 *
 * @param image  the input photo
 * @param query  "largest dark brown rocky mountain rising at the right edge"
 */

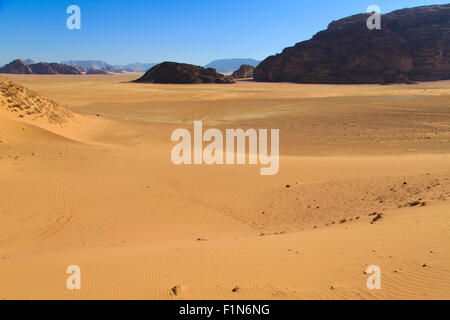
xmin=254 ymin=5 xmax=450 ymax=83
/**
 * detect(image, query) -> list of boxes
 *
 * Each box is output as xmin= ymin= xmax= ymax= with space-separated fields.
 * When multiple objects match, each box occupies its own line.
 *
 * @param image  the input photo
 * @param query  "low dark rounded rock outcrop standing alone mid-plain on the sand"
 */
xmin=135 ymin=62 xmax=235 ymax=84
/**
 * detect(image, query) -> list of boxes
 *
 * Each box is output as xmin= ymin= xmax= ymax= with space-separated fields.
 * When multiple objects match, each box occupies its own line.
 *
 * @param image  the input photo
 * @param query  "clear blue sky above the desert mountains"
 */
xmin=0 ymin=0 xmax=448 ymax=65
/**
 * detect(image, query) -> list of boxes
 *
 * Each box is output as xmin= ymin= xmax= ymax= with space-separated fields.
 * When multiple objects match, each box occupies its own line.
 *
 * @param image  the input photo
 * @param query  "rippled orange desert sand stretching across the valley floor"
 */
xmin=0 ymin=74 xmax=450 ymax=299
